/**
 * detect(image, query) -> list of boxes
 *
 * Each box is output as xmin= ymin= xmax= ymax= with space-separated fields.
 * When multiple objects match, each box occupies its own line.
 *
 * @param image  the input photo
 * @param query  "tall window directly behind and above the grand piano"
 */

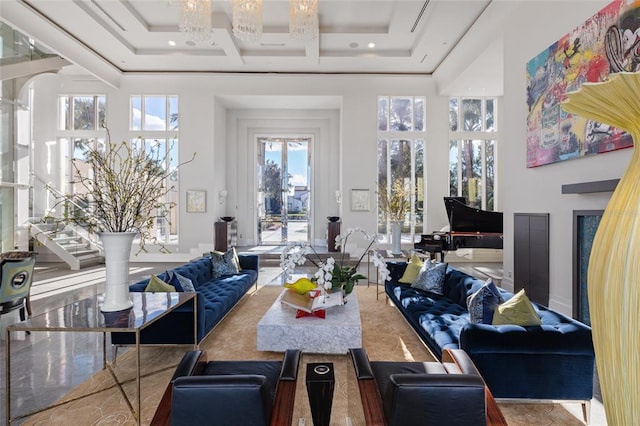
xmin=449 ymin=98 xmax=498 ymax=210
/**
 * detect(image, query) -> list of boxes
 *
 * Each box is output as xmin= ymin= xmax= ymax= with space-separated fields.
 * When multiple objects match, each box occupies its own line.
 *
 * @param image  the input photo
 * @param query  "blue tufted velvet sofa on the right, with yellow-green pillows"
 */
xmin=385 ymin=262 xmax=595 ymax=408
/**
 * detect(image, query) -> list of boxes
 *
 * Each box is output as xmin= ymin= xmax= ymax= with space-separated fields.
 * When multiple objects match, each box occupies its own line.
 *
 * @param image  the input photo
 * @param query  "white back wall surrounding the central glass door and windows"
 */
xmin=34 ymin=74 xmax=448 ymax=259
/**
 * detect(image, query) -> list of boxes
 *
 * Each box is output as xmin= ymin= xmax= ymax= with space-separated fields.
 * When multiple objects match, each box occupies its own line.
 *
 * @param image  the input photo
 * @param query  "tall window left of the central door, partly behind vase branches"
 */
xmin=129 ymin=95 xmax=180 ymax=244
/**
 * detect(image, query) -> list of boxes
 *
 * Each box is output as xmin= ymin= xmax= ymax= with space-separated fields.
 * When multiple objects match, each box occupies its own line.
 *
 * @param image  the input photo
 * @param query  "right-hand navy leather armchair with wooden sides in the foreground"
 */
xmin=349 ymin=348 xmax=506 ymax=426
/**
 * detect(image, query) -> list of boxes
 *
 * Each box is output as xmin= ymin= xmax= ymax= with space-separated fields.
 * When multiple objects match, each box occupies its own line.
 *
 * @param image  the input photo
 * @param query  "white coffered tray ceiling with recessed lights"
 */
xmin=0 ymin=0 xmax=509 ymax=91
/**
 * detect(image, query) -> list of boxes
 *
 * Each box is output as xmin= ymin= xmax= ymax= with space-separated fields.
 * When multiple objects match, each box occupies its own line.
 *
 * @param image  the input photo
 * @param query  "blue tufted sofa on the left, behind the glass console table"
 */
xmin=111 ymin=254 xmax=259 ymax=345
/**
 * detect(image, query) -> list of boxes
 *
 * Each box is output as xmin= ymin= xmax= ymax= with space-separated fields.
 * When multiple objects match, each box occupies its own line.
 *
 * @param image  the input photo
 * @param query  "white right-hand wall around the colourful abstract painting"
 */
xmin=500 ymin=1 xmax=631 ymax=314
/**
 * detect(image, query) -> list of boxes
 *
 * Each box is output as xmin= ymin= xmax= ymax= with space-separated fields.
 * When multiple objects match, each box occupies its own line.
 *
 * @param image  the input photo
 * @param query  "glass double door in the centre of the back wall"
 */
xmin=257 ymin=137 xmax=311 ymax=245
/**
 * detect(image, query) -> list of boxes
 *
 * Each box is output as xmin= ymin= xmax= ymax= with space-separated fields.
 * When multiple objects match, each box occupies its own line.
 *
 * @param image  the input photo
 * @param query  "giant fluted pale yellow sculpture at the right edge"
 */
xmin=562 ymin=73 xmax=640 ymax=426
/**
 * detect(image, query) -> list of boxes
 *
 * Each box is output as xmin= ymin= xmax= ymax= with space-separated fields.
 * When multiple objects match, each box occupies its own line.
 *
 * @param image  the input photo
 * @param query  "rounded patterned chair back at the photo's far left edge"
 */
xmin=0 ymin=256 xmax=36 ymax=312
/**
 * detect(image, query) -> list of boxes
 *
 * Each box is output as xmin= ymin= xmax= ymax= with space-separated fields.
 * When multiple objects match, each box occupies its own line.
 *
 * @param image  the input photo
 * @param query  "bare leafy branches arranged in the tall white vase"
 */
xmin=45 ymin=129 xmax=195 ymax=252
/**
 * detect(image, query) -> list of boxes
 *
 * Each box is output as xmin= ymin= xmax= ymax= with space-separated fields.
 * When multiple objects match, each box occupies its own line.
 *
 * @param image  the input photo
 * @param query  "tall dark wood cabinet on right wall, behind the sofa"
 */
xmin=513 ymin=213 xmax=549 ymax=306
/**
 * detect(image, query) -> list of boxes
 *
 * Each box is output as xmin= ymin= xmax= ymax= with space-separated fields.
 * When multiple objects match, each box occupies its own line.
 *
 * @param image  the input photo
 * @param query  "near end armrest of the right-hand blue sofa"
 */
xmin=460 ymin=321 xmax=595 ymax=400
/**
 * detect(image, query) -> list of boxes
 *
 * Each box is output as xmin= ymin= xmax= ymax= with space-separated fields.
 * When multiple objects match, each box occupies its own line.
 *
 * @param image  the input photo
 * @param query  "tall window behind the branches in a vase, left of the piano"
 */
xmin=378 ymin=96 xmax=426 ymax=241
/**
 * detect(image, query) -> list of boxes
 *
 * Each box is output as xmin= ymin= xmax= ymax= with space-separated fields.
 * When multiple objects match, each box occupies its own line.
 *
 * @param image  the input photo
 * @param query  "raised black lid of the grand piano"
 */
xmin=444 ymin=197 xmax=503 ymax=234
